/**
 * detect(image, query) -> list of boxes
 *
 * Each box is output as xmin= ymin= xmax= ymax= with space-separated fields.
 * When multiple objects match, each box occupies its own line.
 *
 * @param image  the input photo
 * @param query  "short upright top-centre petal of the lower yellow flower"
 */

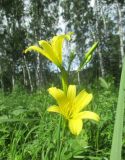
xmin=67 ymin=85 xmax=76 ymax=100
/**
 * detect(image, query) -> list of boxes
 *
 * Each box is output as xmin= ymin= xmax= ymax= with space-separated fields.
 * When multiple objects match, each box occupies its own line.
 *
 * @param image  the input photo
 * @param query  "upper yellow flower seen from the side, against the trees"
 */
xmin=25 ymin=32 xmax=73 ymax=67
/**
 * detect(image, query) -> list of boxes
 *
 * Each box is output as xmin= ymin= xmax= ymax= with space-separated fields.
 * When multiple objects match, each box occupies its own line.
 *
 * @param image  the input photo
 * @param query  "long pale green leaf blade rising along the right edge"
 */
xmin=110 ymin=57 xmax=125 ymax=160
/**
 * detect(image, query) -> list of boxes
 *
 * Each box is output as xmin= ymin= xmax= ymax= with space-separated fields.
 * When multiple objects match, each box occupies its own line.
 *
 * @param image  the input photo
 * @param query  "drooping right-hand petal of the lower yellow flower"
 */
xmin=77 ymin=111 xmax=100 ymax=121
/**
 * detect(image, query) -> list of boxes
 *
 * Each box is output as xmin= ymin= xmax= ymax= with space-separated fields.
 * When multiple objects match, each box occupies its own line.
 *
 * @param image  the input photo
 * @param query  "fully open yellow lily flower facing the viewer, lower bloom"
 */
xmin=47 ymin=85 xmax=100 ymax=135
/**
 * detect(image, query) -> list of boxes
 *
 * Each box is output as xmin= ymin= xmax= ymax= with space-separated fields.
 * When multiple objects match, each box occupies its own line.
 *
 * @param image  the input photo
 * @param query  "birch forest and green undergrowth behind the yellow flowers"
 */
xmin=0 ymin=0 xmax=125 ymax=160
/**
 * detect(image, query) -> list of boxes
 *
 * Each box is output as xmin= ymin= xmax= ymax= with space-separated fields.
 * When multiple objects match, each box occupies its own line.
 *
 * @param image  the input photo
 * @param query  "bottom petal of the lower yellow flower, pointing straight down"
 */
xmin=69 ymin=118 xmax=83 ymax=135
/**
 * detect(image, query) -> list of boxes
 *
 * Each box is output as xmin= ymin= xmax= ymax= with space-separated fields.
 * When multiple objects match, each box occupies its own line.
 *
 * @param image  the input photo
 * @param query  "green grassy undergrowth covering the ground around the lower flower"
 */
xmin=0 ymin=80 xmax=124 ymax=160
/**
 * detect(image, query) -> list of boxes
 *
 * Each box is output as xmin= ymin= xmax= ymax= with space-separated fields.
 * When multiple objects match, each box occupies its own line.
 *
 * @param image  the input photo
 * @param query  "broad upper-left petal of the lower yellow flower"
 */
xmin=48 ymin=87 xmax=66 ymax=105
